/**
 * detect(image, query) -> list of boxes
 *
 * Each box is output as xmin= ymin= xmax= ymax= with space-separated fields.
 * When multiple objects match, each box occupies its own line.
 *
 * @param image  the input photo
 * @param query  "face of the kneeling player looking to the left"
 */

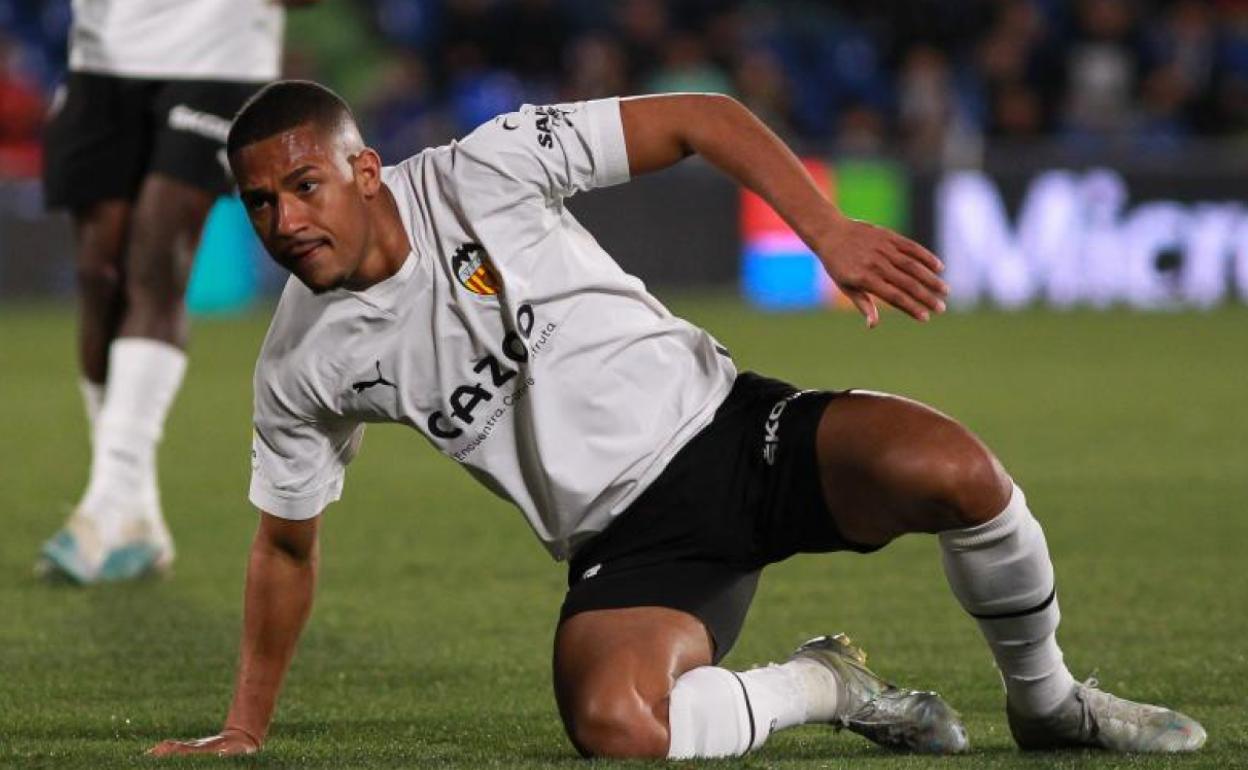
xmin=231 ymin=125 xmax=369 ymax=293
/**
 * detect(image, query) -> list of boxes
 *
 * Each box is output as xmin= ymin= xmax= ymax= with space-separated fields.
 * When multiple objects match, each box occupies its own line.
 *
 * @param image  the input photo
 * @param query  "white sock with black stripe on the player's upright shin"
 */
xmin=940 ymin=485 xmax=1075 ymax=716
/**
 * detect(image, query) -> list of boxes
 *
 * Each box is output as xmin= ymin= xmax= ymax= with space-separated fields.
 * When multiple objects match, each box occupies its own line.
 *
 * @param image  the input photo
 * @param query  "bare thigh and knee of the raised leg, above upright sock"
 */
xmin=816 ymin=391 xmax=1011 ymax=545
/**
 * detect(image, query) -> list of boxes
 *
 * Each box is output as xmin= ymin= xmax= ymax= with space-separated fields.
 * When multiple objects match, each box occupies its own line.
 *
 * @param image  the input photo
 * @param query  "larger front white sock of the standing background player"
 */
xmin=79 ymin=337 xmax=186 ymax=543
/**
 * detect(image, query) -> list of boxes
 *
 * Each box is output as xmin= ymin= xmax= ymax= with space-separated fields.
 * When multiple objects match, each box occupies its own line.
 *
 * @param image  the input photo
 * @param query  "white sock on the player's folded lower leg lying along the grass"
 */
xmin=668 ymin=658 xmax=839 ymax=759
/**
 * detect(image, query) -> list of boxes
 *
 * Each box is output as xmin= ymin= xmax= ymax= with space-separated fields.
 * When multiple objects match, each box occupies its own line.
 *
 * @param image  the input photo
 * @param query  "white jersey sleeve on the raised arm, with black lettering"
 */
xmin=456 ymin=99 xmax=629 ymax=200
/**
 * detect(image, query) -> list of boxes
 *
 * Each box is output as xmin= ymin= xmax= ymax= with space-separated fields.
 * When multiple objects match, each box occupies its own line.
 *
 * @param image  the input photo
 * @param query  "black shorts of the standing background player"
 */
xmin=44 ymin=72 xmax=260 ymax=208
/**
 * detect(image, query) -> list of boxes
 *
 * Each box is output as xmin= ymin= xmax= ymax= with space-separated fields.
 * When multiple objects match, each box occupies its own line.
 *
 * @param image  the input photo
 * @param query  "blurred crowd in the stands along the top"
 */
xmin=0 ymin=0 xmax=1248 ymax=176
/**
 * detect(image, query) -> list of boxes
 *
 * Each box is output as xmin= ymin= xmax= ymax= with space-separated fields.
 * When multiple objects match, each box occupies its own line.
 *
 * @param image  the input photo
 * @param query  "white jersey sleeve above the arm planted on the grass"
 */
xmin=248 ymin=371 xmax=364 ymax=520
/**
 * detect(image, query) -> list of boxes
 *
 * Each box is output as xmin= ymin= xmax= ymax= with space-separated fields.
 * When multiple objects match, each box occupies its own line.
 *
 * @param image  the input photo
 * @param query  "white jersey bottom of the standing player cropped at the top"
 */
xmin=70 ymin=0 xmax=286 ymax=82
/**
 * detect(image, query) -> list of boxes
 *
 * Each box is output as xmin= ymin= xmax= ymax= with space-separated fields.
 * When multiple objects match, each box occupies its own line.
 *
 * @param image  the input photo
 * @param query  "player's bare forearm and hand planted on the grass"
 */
xmin=150 ymin=513 xmax=321 ymax=756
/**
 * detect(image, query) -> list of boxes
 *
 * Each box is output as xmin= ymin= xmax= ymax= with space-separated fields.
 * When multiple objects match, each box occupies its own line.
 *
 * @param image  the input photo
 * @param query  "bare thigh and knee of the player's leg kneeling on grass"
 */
xmin=553 ymin=607 xmax=713 ymax=756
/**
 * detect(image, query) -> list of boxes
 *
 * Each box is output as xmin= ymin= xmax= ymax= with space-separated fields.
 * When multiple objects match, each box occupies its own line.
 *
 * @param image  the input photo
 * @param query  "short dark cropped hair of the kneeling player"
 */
xmin=226 ymin=80 xmax=356 ymax=156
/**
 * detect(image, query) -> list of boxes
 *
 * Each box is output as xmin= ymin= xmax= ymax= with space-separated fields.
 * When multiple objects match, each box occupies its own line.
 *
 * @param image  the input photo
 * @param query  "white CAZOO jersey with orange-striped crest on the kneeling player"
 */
xmin=250 ymin=100 xmax=736 ymax=558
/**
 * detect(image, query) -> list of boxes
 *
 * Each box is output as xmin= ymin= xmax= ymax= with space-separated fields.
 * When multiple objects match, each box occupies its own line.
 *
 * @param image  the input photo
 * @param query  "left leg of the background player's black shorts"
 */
xmin=44 ymin=72 xmax=152 ymax=212
